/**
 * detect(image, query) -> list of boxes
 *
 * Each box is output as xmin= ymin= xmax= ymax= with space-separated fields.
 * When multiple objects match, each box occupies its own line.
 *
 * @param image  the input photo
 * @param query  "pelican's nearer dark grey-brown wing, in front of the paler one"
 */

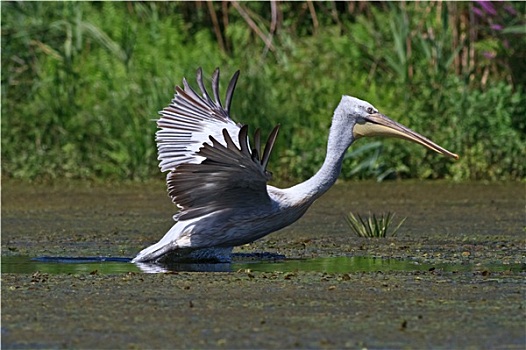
xmin=168 ymin=125 xmax=279 ymax=220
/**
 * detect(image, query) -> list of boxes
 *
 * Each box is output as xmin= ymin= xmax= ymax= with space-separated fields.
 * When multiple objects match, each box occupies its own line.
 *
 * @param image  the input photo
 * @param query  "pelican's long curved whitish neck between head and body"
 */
xmin=287 ymin=110 xmax=353 ymax=205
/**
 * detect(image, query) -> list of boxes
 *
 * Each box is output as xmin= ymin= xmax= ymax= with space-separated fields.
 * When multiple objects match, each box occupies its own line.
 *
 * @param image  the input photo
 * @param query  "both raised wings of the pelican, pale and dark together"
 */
xmin=156 ymin=69 xmax=279 ymax=220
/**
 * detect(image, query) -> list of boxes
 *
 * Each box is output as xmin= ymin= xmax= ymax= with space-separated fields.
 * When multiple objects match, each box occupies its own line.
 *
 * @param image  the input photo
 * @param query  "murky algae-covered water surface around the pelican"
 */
xmin=1 ymin=180 xmax=526 ymax=349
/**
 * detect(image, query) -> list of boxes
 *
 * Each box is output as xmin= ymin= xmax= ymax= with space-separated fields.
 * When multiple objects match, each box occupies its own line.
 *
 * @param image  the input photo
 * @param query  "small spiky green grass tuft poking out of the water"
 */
xmin=346 ymin=212 xmax=407 ymax=238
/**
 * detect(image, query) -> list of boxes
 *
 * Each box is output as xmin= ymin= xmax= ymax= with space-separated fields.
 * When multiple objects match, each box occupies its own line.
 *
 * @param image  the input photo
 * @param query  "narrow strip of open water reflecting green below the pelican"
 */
xmin=2 ymin=256 xmax=526 ymax=274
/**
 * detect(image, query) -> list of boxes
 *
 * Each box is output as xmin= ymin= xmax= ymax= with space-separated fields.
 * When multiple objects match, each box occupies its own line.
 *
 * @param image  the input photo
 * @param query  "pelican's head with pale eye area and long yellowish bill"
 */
xmin=335 ymin=96 xmax=458 ymax=159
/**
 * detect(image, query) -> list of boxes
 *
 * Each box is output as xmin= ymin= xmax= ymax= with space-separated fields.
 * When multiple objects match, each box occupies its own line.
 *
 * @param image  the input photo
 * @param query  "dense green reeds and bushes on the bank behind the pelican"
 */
xmin=1 ymin=2 xmax=526 ymax=181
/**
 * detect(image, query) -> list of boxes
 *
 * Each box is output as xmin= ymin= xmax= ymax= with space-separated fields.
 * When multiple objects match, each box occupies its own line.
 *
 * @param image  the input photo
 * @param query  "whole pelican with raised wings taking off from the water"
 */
xmin=132 ymin=68 xmax=458 ymax=263
